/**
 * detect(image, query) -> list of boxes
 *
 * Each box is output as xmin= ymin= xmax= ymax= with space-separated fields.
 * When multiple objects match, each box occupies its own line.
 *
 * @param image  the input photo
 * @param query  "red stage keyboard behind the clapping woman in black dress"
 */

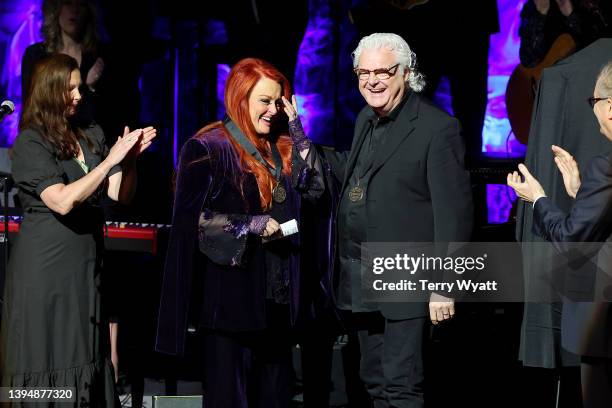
xmin=0 ymin=216 xmax=170 ymax=255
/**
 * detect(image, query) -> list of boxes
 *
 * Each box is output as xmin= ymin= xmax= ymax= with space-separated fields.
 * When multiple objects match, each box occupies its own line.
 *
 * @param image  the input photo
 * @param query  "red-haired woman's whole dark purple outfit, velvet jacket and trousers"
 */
xmin=156 ymin=127 xmax=323 ymax=408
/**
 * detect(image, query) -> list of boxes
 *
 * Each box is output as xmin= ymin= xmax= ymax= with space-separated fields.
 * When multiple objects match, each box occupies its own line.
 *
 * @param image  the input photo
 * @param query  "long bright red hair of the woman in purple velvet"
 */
xmin=197 ymin=58 xmax=292 ymax=210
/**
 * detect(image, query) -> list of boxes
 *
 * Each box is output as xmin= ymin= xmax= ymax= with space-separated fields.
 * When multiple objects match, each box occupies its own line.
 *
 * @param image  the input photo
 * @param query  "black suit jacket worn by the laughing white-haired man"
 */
xmin=325 ymin=92 xmax=473 ymax=319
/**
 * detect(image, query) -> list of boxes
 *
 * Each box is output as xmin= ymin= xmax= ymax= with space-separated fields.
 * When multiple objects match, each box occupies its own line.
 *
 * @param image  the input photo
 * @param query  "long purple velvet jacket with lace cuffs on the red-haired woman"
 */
xmin=156 ymin=129 xmax=324 ymax=355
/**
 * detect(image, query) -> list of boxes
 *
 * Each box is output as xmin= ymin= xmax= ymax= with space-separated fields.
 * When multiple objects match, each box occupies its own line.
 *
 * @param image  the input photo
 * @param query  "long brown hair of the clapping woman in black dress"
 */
xmin=19 ymin=54 xmax=91 ymax=160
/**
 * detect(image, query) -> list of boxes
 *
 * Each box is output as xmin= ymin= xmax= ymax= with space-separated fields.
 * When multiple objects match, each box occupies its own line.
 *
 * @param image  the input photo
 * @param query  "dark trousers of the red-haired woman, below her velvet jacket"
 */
xmin=203 ymin=330 xmax=293 ymax=408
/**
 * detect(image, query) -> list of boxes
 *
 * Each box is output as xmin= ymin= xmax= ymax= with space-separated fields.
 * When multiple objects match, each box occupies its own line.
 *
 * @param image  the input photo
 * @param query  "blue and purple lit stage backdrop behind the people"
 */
xmin=0 ymin=0 xmax=525 ymax=222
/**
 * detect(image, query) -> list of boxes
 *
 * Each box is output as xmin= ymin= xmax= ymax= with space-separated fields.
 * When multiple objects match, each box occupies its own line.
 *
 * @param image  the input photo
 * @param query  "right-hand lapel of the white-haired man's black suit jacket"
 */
xmin=372 ymin=92 xmax=419 ymax=174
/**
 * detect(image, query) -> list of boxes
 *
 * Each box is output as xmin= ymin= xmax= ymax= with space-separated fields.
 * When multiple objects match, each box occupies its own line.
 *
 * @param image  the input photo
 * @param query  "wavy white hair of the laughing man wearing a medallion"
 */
xmin=351 ymin=33 xmax=425 ymax=92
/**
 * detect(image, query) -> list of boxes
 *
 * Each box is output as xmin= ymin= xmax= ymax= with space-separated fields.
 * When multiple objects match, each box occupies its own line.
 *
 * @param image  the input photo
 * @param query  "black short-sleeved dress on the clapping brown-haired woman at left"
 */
xmin=0 ymin=126 xmax=121 ymax=407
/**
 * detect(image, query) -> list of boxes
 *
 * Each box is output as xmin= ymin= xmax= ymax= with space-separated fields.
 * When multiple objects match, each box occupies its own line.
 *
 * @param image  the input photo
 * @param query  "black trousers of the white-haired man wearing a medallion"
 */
xmin=358 ymin=312 xmax=427 ymax=408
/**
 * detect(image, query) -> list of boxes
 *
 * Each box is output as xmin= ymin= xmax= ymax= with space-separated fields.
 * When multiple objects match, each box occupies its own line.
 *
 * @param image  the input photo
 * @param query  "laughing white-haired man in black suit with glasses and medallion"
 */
xmin=285 ymin=33 xmax=473 ymax=408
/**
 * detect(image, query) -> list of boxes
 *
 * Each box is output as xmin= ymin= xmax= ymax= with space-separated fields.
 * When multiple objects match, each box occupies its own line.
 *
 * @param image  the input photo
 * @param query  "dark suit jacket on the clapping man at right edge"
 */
xmin=533 ymin=152 xmax=612 ymax=357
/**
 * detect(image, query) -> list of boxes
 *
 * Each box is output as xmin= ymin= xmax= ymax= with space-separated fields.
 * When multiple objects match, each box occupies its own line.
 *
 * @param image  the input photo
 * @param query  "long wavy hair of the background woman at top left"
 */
xmin=41 ymin=0 xmax=98 ymax=54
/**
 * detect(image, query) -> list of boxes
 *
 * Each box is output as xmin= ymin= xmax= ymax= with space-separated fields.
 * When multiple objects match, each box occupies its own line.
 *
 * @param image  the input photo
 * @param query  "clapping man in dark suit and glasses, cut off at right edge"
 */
xmin=507 ymin=61 xmax=612 ymax=408
